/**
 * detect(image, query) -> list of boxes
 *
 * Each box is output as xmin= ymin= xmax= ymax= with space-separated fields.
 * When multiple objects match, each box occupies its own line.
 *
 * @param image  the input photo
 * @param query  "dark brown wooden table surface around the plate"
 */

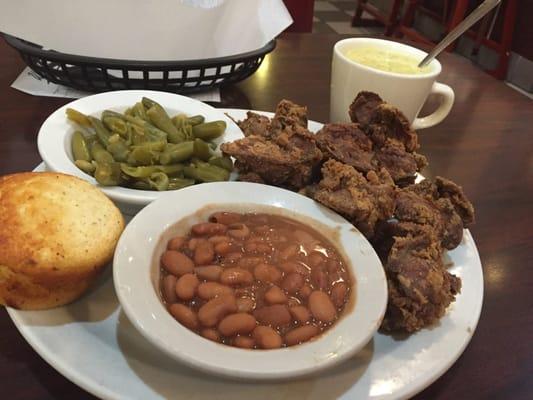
xmin=0 ymin=34 xmax=533 ymax=400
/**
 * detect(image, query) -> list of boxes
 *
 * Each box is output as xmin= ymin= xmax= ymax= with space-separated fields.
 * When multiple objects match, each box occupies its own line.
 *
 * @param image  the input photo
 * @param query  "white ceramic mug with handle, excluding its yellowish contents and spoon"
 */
xmin=330 ymin=38 xmax=455 ymax=129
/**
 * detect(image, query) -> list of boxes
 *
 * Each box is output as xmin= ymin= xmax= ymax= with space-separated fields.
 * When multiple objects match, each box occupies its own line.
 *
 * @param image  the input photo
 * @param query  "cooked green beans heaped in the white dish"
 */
xmin=66 ymin=97 xmax=233 ymax=190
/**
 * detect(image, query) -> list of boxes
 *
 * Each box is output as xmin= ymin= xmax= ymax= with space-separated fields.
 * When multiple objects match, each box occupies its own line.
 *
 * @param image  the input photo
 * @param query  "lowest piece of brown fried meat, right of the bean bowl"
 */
xmin=373 ymin=221 xmax=461 ymax=332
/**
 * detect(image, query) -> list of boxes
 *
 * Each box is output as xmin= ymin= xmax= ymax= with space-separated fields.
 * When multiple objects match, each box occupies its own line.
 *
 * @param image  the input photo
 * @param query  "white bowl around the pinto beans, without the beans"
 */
xmin=113 ymin=182 xmax=387 ymax=379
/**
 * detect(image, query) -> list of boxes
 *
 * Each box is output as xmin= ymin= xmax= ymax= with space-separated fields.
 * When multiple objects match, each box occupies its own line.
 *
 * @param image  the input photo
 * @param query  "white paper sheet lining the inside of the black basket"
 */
xmin=0 ymin=0 xmax=292 ymax=61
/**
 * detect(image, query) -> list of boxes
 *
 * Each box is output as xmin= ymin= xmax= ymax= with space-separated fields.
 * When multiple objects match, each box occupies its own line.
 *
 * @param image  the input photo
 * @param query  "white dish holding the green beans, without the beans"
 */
xmin=37 ymin=90 xmax=242 ymax=214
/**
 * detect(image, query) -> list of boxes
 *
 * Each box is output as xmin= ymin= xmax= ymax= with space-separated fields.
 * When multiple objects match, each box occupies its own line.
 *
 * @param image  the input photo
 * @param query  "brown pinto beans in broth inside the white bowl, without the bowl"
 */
xmin=160 ymin=211 xmax=352 ymax=349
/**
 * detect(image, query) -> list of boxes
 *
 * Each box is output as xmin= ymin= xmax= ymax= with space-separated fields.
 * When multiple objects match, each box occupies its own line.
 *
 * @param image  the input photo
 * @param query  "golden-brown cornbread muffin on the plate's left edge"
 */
xmin=0 ymin=172 xmax=124 ymax=310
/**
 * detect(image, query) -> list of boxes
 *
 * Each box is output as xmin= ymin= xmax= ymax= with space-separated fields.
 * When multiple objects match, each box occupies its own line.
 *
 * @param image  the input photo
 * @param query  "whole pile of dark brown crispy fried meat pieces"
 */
xmin=221 ymin=92 xmax=474 ymax=332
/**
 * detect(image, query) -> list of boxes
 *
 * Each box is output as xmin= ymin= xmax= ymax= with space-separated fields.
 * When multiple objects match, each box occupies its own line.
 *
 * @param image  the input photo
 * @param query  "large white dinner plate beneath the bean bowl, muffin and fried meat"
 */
xmin=8 ymin=110 xmax=483 ymax=400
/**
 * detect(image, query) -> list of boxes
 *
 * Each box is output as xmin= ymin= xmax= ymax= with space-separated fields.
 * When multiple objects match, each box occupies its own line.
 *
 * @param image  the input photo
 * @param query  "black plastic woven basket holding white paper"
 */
xmin=2 ymin=33 xmax=276 ymax=94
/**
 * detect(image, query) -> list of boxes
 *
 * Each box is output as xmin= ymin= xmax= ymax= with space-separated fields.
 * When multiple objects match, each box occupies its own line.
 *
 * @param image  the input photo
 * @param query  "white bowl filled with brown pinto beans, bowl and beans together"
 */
xmin=114 ymin=182 xmax=387 ymax=379
